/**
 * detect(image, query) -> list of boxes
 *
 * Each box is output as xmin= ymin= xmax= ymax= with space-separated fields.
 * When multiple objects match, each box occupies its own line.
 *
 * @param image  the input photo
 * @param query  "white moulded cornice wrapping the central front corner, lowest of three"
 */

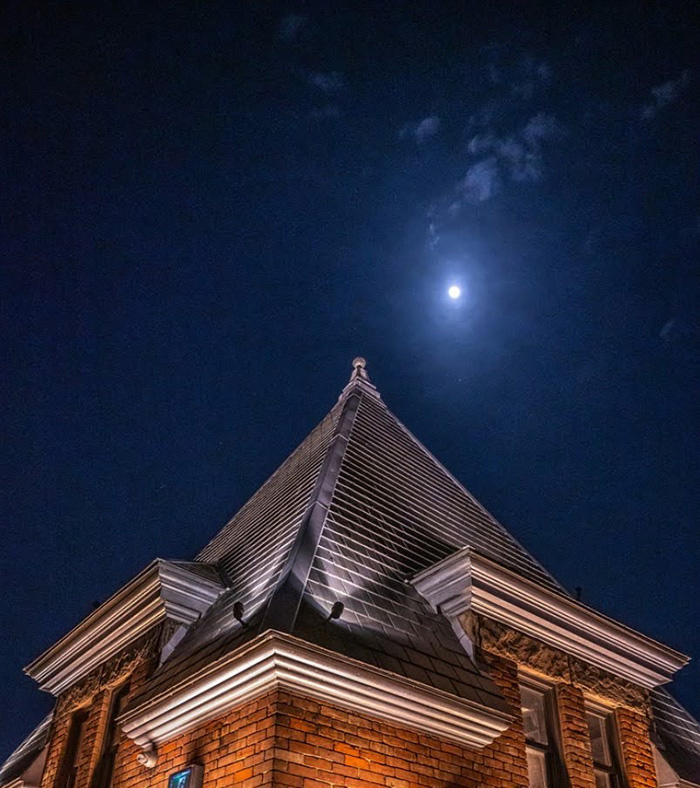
xmin=120 ymin=630 xmax=511 ymax=748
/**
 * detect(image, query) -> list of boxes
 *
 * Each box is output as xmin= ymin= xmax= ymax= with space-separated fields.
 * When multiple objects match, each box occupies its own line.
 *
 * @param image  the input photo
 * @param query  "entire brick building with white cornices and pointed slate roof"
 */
xmin=0 ymin=359 xmax=700 ymax=788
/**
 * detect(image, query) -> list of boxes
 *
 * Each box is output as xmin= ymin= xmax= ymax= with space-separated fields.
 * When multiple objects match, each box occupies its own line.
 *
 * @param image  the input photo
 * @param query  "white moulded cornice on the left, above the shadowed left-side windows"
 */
xmin=25 ymin=559 xmax=223 ymax=695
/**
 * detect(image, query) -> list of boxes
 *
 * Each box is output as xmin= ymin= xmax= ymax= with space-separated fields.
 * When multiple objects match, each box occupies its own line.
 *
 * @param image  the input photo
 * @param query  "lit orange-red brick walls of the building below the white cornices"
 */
xmin=42 ymin=640 xmax=656 ymax=788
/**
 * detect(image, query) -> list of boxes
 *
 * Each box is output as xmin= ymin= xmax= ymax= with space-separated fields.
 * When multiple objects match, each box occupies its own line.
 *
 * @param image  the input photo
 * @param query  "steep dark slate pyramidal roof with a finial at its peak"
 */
xmin=134 ymin=358 xmax=566 ymax=707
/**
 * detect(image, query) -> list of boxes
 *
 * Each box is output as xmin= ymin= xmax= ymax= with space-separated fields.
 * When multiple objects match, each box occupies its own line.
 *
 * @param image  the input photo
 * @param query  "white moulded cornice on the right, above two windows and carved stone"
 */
xmin=411 ymin=548 xmax=688 ymax=688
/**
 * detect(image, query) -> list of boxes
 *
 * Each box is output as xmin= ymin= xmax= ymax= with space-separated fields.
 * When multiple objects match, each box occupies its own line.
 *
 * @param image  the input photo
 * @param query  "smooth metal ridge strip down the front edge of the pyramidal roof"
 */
xmin=259 ymin=389 xmax=362 ymax=633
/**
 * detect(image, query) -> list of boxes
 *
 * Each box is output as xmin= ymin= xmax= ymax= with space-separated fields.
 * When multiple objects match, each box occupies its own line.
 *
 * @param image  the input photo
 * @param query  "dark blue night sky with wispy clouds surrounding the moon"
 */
xmin=0 ymin=0 xmax=700 ymax=757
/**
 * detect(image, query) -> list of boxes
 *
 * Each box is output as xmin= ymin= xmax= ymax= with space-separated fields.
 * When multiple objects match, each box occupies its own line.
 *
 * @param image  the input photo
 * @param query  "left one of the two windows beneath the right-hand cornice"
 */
xmin=520 ymin=684 xmax=564 ymax=788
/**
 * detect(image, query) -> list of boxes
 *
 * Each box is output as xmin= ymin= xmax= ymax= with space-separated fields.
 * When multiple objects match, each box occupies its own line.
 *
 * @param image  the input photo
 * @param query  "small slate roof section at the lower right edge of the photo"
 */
xmin=651 ymin=687 xmax=700 ymax=785
